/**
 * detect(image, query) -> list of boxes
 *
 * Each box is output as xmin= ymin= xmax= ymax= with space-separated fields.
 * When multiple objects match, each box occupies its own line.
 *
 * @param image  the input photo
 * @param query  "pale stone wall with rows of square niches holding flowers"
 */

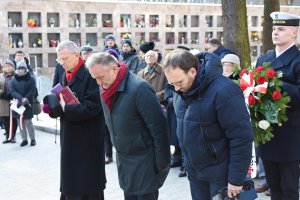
xmin=0 ymin=0 xmax=300 ymax=72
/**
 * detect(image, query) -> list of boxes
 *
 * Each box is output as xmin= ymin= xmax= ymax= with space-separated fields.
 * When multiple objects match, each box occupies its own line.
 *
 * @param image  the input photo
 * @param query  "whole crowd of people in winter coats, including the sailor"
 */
xmin=0 ymin=12 xmax=300 ymax=200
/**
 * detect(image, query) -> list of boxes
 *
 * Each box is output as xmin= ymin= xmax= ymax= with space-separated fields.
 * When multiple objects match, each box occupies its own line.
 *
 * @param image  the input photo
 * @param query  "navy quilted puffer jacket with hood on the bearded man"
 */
xmin=174 ymin=53 xmax=253 ymax=185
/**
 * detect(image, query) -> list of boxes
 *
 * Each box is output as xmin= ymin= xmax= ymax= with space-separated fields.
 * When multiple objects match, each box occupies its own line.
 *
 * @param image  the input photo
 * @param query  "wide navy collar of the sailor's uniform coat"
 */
xmin=270 ymin=45 xmax=299 ymax=69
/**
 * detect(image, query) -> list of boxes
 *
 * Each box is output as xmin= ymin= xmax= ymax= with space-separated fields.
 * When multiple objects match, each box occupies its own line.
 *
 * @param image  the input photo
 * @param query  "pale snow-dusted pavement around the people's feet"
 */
xmin=0 ymin=116 xmax=270 ymax=200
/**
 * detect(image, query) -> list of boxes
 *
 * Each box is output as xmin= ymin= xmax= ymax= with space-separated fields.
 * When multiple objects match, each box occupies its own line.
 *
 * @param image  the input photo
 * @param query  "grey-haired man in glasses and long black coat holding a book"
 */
xmin=49 ymin=41 xmax=106 ymax=200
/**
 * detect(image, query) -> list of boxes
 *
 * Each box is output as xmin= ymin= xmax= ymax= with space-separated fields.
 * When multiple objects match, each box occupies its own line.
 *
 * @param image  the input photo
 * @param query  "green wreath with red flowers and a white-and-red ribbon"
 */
xmin=234 ymin=63 xmax=290 ymax=144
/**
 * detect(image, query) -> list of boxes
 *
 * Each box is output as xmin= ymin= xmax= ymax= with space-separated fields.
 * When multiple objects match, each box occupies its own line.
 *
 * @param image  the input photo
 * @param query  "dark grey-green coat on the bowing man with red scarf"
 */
xmin=102 ymin=71 xmax=170 ymax=195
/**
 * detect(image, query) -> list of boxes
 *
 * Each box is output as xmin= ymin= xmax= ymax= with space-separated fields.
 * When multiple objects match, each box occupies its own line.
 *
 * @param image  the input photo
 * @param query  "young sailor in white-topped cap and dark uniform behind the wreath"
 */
xmin=256 ymin=12 xmax=300 ymax=200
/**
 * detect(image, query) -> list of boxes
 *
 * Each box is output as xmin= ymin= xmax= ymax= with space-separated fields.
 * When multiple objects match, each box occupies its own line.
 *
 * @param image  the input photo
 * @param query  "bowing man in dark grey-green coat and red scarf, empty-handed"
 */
xmin=87 ymin=53 xmax=170 ymax=200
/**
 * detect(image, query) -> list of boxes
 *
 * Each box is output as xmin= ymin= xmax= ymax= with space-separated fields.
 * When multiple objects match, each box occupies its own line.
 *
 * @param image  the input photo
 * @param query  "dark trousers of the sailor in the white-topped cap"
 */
xmin=263 ymin=160 xmax=300 ymax=200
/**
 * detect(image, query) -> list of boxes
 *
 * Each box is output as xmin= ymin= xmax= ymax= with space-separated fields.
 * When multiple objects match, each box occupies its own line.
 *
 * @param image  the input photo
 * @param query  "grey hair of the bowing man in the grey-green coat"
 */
xmin=85 ymin=52 xmax=118 ymax=68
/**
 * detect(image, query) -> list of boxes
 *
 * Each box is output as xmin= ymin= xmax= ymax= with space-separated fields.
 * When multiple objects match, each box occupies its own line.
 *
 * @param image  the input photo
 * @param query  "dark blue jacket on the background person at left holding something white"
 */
xmin=8 ymin=72 xmax=36 ymax=119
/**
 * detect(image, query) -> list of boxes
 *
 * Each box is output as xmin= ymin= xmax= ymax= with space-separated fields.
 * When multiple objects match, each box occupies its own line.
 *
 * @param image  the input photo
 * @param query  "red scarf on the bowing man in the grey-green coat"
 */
xmin=101 ymin=62 xmax=127 ymax=111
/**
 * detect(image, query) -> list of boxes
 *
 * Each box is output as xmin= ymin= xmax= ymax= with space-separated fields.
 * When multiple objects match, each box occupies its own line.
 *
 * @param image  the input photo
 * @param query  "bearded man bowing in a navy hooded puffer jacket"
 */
xmin=164 ymin=49 xmax=253 ymax=200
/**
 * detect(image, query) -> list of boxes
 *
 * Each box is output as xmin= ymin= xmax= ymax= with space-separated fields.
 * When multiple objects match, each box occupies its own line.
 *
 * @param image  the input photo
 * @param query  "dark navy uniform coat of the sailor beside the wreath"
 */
xmin=256 ymin=45 xmax=300 ymax=162
